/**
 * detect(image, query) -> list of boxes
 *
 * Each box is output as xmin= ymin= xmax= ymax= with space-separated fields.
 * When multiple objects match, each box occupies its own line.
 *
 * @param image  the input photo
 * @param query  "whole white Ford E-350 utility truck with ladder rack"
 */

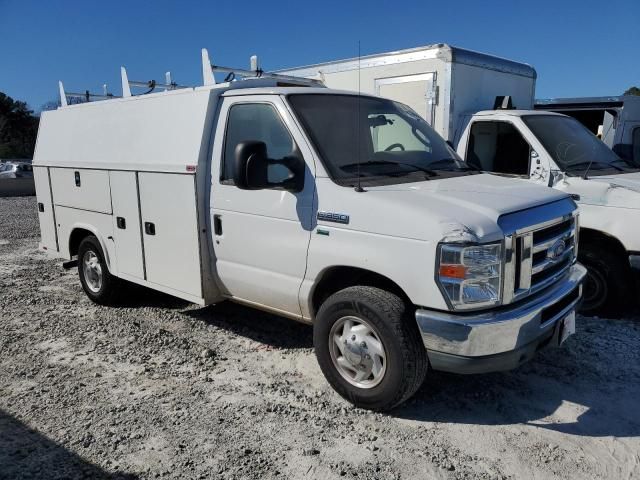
xmin=33 ymin=50 xmax=585 ymax=409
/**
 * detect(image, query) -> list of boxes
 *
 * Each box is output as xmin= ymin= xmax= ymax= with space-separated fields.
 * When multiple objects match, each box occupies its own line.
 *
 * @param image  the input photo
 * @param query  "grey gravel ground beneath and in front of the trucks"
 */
xmin=0 ymin=197 xmax=640 ymax=480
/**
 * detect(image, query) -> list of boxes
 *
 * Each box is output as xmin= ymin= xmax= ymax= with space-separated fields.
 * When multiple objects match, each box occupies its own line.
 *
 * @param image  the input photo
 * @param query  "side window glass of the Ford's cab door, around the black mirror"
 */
xmin=220 ymin=103 xmax=296 ymax=185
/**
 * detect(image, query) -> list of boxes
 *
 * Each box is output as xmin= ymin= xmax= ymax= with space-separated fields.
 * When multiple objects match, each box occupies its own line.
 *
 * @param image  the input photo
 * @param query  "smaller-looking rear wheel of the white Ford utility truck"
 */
xmin=78 ymin=235 xmax=117 ymax=305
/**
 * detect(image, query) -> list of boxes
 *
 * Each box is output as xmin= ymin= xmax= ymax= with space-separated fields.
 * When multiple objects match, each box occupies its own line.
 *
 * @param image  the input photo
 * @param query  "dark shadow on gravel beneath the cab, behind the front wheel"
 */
xmin=182 ymin=302 xmax=313 ymax=349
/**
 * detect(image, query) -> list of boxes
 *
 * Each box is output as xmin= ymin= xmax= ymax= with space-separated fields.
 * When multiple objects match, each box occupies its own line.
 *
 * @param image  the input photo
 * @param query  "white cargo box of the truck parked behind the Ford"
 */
xmin=280 ymin=43 xmax=536 ymax=141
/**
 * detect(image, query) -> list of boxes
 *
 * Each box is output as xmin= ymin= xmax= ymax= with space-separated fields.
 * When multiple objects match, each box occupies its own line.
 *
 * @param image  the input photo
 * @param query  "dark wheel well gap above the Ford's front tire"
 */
xmin=311 ymin=267 xmax=410 ymax=317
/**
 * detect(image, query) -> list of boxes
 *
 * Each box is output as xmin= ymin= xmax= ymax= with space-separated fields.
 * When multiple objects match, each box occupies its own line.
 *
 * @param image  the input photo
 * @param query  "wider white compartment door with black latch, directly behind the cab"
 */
xmin=138 ymin=172 xmax=202 ymax=298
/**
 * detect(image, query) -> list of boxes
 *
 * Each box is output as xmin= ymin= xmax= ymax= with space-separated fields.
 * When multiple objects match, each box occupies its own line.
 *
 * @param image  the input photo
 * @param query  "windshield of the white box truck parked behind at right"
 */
xmin=522 ymin=115 xmax=638 ymax=176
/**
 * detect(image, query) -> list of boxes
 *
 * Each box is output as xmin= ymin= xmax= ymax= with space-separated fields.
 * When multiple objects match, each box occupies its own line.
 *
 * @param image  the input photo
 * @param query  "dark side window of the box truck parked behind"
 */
xmin=466 ymin=122 xmax=531 ymax=176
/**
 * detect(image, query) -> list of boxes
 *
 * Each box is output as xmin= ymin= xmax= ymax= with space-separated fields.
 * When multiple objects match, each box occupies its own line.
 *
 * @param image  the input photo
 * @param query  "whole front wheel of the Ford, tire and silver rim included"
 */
xmin=313 ymin=286 xmax=428 ymax=410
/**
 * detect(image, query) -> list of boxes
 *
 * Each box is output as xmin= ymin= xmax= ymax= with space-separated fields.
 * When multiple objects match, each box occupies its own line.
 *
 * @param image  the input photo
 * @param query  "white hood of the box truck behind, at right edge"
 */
xmin=556 ymin=172 xmax=640 ymax=209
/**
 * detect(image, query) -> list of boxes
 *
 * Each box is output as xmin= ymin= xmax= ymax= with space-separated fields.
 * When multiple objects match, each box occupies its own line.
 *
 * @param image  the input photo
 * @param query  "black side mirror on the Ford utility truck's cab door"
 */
xmin=233 ymin=141 xmax=305 ymax=192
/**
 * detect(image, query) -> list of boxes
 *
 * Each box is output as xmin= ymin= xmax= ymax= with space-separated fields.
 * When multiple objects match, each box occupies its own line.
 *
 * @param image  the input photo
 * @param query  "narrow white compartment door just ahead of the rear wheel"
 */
xmin=109 ymin=171 xmax=144 ymax=279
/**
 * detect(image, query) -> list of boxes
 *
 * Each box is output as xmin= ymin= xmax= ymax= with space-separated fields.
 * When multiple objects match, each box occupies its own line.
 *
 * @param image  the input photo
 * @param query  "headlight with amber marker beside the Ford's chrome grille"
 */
xmin=436 ymin=243 xmax=502 ymax=310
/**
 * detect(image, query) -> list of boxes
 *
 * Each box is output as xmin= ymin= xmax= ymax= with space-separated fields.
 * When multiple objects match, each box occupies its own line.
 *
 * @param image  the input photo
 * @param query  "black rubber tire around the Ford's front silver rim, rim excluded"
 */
xmin=313 ymin=286 xmax=429 ymax=410
